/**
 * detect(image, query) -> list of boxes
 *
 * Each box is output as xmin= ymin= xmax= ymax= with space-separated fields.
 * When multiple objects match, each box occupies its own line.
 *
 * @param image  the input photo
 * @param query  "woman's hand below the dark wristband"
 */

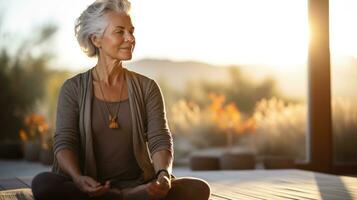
xmin=147 ymin=173 xmax=171 ymax=199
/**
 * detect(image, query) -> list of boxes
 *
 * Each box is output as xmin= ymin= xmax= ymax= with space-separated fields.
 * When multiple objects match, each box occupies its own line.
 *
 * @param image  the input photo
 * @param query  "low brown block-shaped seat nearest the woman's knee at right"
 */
xmin=190 ymin=155 xmax=219 ymax=170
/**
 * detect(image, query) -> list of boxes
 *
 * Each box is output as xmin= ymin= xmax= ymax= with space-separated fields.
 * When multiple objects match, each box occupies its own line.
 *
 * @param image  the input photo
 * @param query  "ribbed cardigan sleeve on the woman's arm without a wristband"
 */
xmin=53 ymin=79 xmax=80 ymax=155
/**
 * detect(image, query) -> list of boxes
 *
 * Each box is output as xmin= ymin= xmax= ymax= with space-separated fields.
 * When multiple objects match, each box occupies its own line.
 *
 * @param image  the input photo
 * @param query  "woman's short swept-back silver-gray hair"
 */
xmin=74 ymin=0 xmax=130 ymax=57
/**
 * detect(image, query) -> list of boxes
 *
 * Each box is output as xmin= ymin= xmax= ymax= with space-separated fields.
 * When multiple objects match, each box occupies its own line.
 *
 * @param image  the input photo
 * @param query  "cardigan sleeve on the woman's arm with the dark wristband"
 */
xmin=146 ymin=80 xmax=173 ymax=156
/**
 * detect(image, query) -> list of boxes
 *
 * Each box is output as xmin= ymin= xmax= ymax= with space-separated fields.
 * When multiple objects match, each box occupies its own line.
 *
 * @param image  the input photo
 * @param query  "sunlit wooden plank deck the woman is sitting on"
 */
xmin=0 ymin=170 xmax=357 ymax=200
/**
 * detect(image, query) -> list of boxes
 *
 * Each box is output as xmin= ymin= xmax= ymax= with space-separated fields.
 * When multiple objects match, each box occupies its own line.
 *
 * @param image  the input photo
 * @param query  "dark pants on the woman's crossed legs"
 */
xmin=31 ymin=172 xmax=210 ymax=200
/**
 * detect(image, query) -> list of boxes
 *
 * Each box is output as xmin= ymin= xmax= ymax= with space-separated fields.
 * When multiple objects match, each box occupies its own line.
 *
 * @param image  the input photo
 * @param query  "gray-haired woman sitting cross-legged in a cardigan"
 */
xmin=32 ymin=0 xmax=210 ymax=200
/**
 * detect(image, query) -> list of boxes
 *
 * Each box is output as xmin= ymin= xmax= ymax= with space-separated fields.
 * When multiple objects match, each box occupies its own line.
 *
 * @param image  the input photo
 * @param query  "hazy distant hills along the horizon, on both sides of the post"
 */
xmin=126 ymin=58 xmax=357 ymax=98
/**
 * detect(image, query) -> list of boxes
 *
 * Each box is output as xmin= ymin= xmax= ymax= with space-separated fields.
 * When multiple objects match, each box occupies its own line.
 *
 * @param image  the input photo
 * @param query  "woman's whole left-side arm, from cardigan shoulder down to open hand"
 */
xmin=53 ymin=79 xmax=110 ymax=196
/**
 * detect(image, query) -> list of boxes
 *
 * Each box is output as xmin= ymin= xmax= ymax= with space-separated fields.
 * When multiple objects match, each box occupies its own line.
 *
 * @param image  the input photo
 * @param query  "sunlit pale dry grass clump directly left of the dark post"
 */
xmin=249 ymin=98 xmax=307 ymax=160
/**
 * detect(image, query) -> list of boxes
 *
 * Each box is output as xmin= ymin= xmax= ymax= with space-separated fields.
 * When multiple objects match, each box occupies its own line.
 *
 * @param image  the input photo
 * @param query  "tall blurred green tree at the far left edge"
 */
xmin=0 ymin=24 xmax=57 ymax=140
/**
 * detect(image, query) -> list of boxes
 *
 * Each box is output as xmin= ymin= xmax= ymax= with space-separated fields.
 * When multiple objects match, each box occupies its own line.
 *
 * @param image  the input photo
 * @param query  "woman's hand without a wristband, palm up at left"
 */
xmin=73 ymin=176 xmax=110 ymax=197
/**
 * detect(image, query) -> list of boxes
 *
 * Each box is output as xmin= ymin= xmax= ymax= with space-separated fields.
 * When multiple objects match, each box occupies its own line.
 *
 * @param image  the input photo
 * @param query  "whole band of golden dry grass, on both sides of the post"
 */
xmin=170 ymin=95 xmax=357 ymax=162
